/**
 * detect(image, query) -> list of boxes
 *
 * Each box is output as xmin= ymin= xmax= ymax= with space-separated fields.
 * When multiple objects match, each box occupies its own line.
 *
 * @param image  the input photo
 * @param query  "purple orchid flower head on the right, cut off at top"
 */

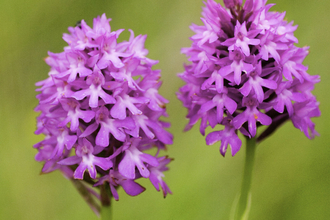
xmin=178 ymin=0 xmax=320 ymax=156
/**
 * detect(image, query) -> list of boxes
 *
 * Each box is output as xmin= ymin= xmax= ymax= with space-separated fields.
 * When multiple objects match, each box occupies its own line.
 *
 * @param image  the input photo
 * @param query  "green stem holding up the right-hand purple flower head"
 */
xmin=235 ymin=137 xmax=256 ymax=220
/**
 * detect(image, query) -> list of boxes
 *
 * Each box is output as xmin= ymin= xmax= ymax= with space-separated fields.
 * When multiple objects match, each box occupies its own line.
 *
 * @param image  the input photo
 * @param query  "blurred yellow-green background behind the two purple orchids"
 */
xmin=0 ymin=0 xmax=330 ymax=220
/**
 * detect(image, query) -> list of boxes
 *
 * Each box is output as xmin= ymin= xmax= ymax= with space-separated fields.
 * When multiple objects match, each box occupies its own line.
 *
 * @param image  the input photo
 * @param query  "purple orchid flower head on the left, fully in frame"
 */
xmin=35 ymin=14 xmax=173 ymax=200
